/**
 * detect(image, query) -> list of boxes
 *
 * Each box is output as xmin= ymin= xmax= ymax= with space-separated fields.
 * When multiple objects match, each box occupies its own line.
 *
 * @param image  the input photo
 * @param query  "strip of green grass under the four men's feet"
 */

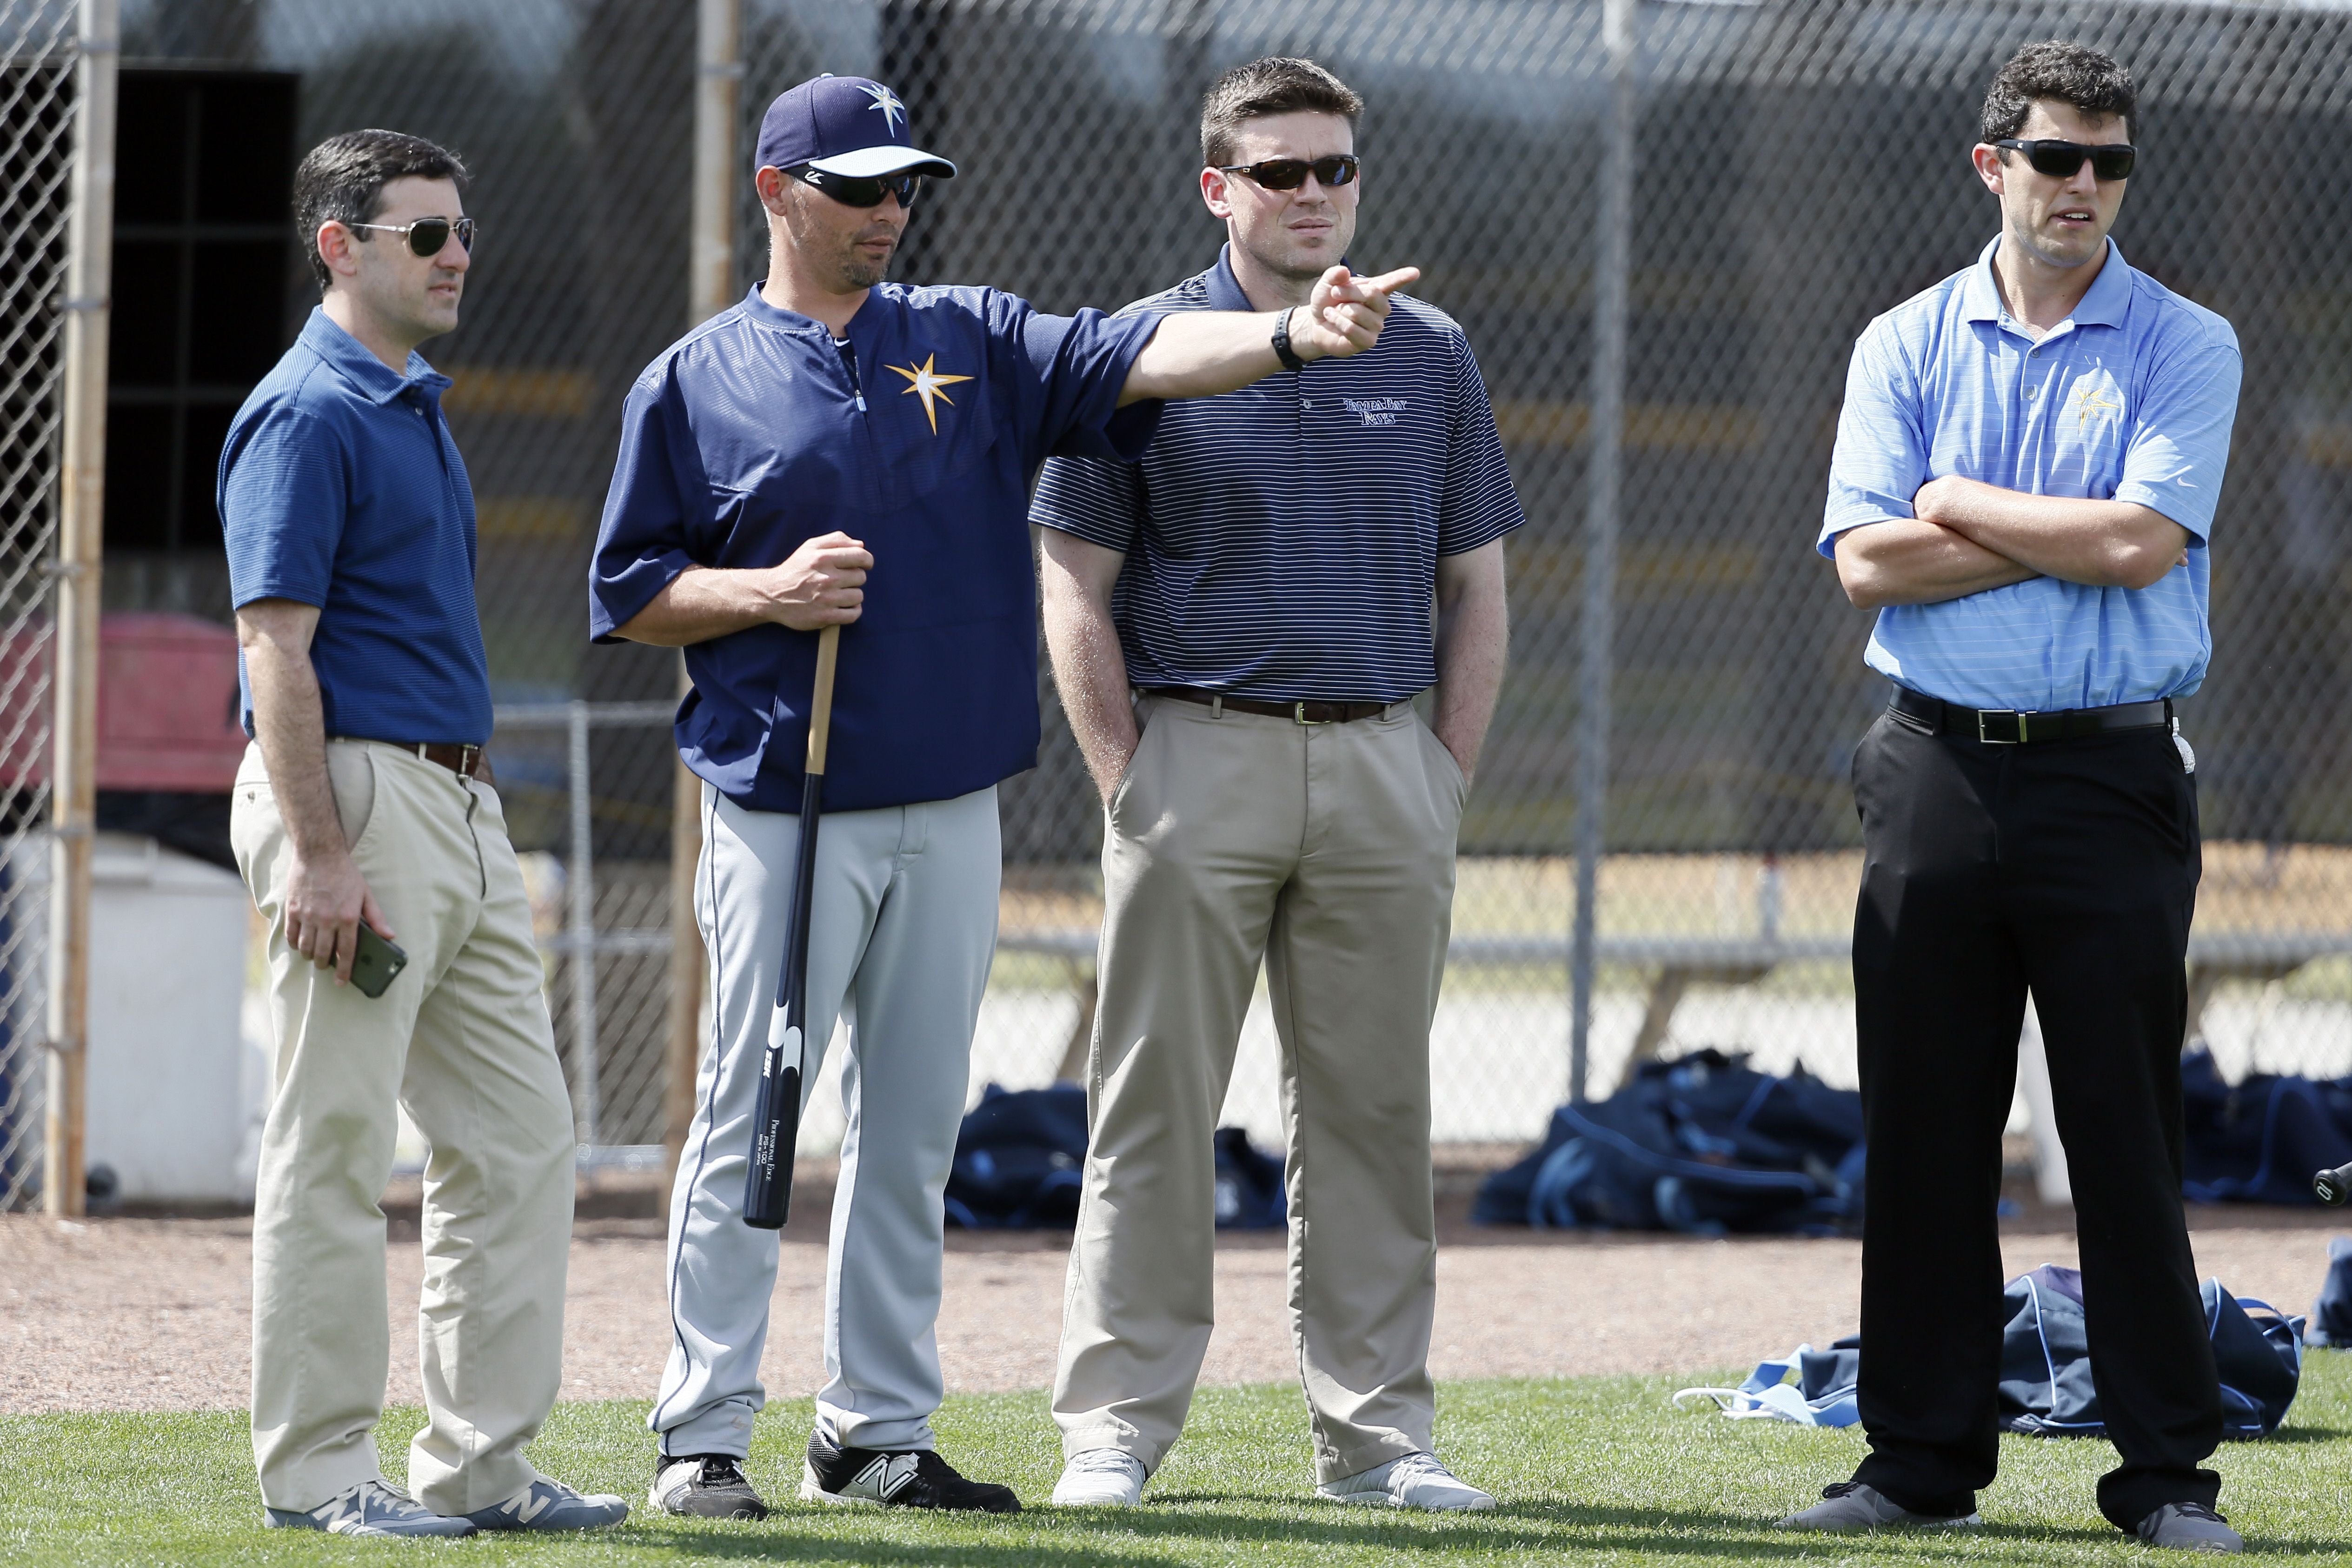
xmin=0 ymin=1354 xmax=2352 ymax=1568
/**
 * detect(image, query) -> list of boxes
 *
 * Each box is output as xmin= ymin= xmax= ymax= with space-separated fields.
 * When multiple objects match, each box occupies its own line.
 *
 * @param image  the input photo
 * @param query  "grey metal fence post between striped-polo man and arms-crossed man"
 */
xmin=1569 ymin=0 xmax=1637 ymax=1103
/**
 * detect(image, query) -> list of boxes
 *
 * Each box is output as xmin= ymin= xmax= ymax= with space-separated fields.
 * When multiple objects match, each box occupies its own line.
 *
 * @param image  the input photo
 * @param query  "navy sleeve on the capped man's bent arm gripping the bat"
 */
xmin=588 ymin=372 xmax=711 ymax=642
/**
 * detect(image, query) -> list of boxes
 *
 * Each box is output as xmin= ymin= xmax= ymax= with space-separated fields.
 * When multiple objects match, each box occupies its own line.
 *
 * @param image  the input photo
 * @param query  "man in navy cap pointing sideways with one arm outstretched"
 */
xmin=591 ymin=75 xmax=1414 ymax=1519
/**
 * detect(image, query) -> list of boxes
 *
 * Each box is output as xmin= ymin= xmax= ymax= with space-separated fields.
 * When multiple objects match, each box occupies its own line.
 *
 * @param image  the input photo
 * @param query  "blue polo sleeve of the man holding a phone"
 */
xmin=219 ymin=402 xmax=351 ymax=609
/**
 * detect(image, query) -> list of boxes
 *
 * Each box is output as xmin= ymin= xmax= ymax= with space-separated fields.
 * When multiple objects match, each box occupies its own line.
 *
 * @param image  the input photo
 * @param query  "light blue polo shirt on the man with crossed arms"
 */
xmin=1820 ymin=240 xmax=2239 ymax=712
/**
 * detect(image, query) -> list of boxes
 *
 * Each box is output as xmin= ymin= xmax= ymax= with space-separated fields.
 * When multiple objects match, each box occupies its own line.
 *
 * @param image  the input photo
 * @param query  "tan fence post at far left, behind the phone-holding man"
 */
xmin=42 ymin=0 xmax=120 ymax=1218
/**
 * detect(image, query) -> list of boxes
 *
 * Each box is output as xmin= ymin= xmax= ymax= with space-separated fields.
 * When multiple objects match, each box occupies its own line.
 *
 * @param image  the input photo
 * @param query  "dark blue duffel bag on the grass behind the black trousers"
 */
xmin=2001 ymin=1262 xmax=2303 ymax=1439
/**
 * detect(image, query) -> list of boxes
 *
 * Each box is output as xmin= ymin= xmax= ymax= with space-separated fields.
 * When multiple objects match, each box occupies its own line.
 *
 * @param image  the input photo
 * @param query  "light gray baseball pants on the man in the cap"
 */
xmin=647 ymin=785 xmax=1002 ymax=1457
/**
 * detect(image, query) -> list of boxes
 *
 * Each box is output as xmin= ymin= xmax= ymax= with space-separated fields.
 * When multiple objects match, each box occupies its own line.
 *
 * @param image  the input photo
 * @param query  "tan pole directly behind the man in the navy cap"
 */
xmin=661 ymin=0 xmax=743 ymax=1183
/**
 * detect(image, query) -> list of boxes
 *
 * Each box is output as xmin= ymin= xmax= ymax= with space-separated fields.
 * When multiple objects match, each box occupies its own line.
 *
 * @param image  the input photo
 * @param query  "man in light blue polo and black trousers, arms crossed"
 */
xmin=1783 ymin=42 xmax=2241 ymax=1552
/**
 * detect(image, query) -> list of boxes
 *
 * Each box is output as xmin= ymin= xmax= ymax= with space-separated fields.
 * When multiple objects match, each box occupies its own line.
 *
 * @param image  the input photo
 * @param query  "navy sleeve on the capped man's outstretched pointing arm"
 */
xmin=990 ymin=294 xmax=1162 ymax=463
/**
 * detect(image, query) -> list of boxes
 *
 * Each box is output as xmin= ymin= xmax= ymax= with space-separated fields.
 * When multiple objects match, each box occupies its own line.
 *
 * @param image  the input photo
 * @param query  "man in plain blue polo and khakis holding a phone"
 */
xmin=219 ymin=132 xmax=628 ymax=1535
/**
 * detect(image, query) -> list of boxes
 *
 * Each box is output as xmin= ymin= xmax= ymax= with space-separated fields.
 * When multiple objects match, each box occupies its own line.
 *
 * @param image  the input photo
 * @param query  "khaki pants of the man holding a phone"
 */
xmin=231 ymin=740 xmax=574 ymax=1514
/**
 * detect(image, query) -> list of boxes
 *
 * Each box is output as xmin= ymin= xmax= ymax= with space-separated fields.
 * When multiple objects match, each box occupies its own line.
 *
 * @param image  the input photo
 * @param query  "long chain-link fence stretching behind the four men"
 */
xmin=50 ymin=0 xmax=2352 ymax=1180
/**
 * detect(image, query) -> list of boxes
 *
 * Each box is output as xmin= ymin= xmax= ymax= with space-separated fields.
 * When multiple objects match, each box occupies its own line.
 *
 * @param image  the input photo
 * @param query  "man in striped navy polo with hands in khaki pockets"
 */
xmin=1030 ymin=59 xmax=1524 ymax=1509
